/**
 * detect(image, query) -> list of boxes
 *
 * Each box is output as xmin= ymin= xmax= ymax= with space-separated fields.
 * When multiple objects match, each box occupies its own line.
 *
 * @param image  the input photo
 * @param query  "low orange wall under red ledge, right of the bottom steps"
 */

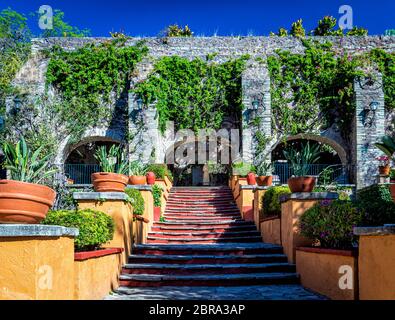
xmin=296 ymin=250 xmax=358 ymax=300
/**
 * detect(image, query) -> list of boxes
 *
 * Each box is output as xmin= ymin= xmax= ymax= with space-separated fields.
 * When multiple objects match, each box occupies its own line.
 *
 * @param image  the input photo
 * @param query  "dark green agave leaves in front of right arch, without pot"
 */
xmin=283 ymin=142 xmax=321 ymax=177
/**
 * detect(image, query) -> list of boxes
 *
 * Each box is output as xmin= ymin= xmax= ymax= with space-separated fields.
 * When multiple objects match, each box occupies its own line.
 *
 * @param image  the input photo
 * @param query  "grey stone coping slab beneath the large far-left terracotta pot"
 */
xmin=0 ymin=224 xmax=79 ymax=237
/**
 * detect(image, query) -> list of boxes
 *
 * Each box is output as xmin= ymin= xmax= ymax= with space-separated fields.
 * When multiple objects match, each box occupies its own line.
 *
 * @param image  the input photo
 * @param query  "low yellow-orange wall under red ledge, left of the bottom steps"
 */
xmin=74 ymin=253 xmax=122 ymax=300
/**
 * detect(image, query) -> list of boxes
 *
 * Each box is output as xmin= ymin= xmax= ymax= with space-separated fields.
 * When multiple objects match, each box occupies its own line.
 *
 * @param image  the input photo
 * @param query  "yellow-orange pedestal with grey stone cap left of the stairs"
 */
xmin=73 ymin=192 xmax=133 ymax=263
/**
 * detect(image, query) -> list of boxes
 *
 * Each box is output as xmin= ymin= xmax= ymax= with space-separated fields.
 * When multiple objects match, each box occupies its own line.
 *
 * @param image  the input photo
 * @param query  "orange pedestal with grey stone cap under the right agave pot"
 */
xmin=280 ymin=192 xmax=339 ymax=263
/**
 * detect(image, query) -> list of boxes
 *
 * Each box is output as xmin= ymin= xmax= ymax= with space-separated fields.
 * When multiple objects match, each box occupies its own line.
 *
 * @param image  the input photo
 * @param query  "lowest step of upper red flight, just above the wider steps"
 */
xmin=147 ymin=236 xmax=262 ymax=244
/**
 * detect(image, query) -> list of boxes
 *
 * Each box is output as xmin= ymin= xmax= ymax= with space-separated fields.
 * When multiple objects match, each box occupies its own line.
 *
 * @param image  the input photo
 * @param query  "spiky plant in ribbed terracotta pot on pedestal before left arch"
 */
xmin=91 ymin=145 xmax=129 ymax=192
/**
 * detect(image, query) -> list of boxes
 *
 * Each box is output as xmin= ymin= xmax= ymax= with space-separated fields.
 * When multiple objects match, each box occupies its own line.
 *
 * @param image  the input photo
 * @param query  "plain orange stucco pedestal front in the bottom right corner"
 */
xmin=358 ymin=235 xmax=395 ymax=300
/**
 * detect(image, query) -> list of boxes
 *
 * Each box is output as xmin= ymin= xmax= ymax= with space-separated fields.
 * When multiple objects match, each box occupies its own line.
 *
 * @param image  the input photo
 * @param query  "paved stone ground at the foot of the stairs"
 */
xmin=105 ymin=285 xmax=326 ymax=300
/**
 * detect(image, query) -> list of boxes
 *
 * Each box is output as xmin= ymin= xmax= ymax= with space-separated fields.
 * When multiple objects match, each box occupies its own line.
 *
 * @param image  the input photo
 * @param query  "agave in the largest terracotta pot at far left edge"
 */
xmin=0 ymin=137 xmax=56 ymax=224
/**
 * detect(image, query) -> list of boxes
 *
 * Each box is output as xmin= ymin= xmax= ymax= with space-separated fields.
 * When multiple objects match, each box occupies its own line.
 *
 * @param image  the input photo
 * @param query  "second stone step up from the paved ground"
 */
xmin=122 ymin=263 xmax=295 ymax=275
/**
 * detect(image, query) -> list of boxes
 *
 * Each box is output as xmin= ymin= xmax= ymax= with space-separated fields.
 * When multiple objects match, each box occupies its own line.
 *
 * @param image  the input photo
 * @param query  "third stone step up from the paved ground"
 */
xmin=129 ymin=253 xmax=287 ymax=264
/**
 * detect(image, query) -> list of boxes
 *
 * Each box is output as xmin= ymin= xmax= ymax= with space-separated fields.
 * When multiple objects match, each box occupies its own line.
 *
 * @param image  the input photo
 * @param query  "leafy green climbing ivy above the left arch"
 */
xmin=46 ymin=38 xmax=148 ymax=141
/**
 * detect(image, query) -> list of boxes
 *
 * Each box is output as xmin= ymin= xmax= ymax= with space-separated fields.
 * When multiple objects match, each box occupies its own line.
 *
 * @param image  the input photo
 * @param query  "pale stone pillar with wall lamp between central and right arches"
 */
xmin=241 ymin=61 xmax=272 ymax=163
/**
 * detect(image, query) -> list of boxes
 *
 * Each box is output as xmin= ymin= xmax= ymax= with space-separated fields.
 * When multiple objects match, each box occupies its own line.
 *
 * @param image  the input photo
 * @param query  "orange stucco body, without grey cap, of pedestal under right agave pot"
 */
xmin=281 ymin=199 xmax=317 ymax=263
